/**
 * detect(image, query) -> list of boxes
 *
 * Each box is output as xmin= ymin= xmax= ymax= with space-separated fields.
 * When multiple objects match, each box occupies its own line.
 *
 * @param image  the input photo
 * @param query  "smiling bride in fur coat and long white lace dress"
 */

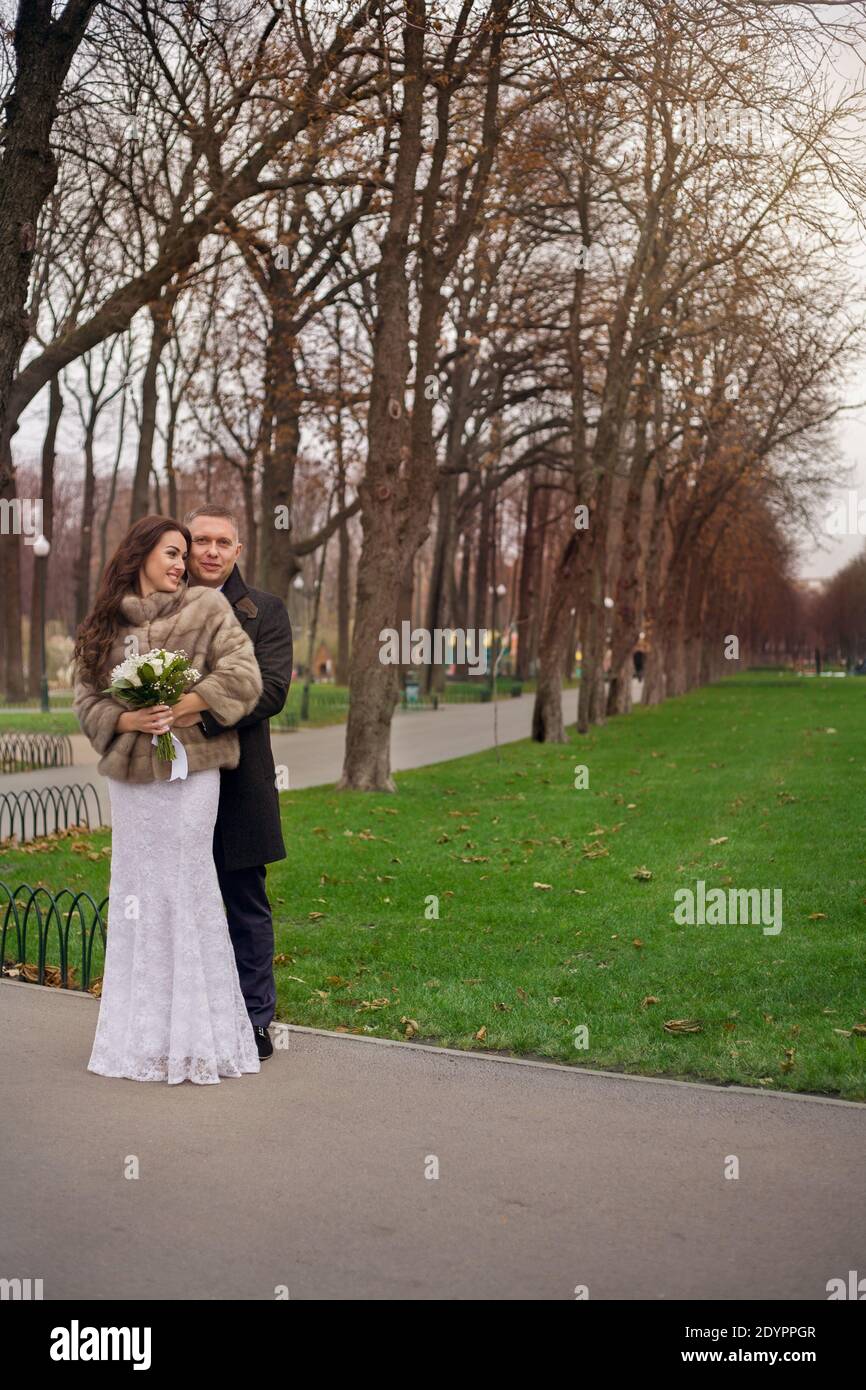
xmin=72 ymin=516 xmax=261 ymax=1084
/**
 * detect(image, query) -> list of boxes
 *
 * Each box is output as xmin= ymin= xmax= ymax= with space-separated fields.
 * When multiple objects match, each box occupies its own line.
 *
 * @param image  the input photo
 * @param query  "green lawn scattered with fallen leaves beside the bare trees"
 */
xmin=0 ymin=673 xmax=866 ymax=1099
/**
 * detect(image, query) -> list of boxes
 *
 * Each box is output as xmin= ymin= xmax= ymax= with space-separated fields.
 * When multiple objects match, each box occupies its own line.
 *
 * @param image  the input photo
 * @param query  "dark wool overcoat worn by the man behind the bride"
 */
xmin=202 ymin=566 xmax=292 ymax=869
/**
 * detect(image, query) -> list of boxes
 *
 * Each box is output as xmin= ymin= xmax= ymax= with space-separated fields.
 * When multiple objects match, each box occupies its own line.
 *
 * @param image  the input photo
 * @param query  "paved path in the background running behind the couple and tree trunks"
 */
xmin=0 ymin=689 xmax=577 ymax=823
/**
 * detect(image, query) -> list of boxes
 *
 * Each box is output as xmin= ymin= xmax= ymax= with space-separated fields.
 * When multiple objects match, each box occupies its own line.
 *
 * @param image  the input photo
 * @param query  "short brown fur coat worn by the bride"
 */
xmin=72 ymin=584 xmax=261 ymax=783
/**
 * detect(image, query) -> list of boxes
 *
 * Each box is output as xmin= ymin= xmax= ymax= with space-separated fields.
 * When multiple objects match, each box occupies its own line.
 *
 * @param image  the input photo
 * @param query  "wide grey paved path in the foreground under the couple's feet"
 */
xmin=0 ymin=981 xmax=866 ymax=1301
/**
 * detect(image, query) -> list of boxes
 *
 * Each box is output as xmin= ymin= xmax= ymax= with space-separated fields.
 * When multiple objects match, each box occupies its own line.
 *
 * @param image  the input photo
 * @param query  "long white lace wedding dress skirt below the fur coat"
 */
xmin=88 ymin=769 xmax=261 ymax=1086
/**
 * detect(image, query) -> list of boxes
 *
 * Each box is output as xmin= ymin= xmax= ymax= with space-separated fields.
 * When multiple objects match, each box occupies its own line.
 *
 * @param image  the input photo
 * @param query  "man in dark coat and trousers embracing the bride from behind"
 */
xmin=183 ymin=506 xmax=292 ymax=1058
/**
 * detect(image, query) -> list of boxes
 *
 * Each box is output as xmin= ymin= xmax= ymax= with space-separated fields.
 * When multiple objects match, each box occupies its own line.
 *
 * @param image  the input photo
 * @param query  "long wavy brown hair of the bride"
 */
xmin=72 ymin=516 xmax=192 ymax=689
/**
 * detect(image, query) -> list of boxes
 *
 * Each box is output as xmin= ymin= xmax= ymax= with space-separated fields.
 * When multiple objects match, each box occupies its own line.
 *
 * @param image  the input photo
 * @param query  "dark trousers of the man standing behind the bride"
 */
xmin=214 ymin=838 xmax=277 ymax=1029
